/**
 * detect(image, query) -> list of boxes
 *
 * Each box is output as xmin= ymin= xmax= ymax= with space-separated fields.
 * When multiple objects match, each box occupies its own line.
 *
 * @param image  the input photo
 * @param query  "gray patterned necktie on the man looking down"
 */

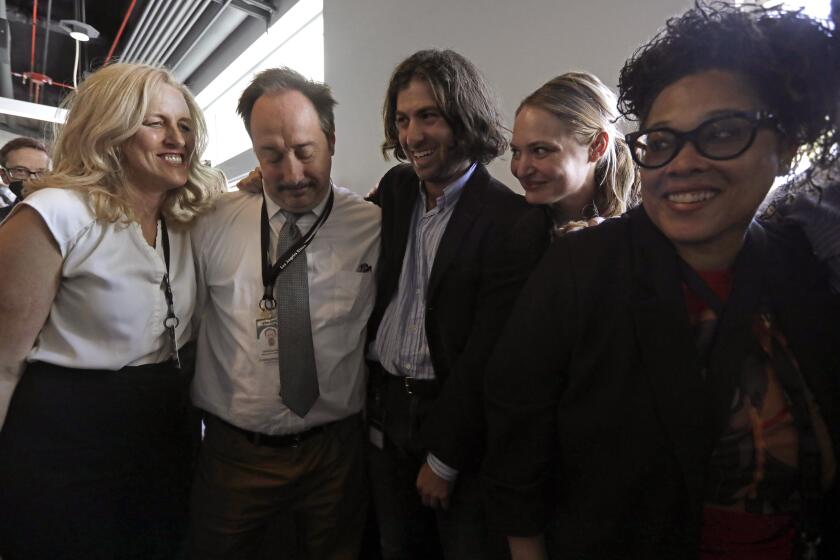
xmin=274 ymin=212 xmax=319 ymax=418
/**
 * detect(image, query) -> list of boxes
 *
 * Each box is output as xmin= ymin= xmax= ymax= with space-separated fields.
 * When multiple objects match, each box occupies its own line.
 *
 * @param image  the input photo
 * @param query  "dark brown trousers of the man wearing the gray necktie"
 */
xmin=190 ymin=415 xmax=368 ymax=560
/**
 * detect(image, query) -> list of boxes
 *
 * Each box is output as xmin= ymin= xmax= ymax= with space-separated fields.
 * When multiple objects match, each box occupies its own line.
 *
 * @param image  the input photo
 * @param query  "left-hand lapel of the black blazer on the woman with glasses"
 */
xmin=629 ymin=207 xmax=708 ymax=499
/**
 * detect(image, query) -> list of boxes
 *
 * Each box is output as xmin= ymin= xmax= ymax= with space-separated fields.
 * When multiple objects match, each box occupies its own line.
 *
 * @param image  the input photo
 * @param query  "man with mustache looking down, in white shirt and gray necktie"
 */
xmin=190 ymin=68 xmax=380 ymax=559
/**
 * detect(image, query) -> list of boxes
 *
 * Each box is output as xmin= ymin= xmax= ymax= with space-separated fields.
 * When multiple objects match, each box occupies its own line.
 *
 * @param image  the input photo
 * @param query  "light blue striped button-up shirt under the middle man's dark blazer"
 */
xmin=371 ymin=163 xmax=476 ymax=379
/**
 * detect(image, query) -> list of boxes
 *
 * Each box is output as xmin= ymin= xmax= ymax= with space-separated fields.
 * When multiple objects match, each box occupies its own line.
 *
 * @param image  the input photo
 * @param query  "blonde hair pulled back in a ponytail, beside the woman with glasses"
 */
xmin=516 ymin=72 xmax=639 ymax=218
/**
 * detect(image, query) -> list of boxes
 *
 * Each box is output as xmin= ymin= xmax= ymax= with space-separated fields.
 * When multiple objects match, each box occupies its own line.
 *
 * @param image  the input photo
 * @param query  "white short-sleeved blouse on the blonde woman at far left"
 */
xmin=22 ymin=189 xmax=195 ymax=370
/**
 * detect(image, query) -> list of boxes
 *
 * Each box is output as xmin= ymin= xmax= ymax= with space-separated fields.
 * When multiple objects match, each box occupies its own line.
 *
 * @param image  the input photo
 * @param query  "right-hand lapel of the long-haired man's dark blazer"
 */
xmin=426 ymin=164 xmax=490 ymax=302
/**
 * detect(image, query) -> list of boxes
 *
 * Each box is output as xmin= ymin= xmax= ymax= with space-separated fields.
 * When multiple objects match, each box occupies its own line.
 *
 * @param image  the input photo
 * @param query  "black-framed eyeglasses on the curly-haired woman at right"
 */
xmin=624 ymin=111 xmax=779 ymax=169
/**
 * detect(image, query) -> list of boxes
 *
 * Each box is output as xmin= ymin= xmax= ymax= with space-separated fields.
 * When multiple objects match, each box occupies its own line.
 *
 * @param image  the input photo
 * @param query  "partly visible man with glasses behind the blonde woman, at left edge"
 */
xmin=0 ymin=136 xmax=50 ymax=221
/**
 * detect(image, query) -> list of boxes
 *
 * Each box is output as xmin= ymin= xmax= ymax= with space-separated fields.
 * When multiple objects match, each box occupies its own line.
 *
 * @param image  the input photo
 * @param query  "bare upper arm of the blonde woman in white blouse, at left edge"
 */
xmin=0 ymin=208 xmax=62 ymax=427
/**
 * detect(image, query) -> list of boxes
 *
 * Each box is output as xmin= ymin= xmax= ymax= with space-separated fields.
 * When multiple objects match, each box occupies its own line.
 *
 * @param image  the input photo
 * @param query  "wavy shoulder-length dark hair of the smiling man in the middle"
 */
xmin=382 ymin=49 xmax=507 ymax=163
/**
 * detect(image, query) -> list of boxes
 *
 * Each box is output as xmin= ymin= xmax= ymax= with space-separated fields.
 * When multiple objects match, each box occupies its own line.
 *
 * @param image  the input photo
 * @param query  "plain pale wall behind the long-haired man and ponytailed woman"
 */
xmin=324 ymin=0 xmax=691 ymax=193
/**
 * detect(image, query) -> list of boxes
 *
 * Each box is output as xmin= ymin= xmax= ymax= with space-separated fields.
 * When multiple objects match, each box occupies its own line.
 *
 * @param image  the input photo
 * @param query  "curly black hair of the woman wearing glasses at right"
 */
xmin=618 ymin=1 xmax=840 ymax=170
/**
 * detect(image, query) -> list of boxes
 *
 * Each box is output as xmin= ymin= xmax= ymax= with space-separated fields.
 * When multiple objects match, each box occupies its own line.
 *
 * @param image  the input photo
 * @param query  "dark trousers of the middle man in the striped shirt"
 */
xmin=368 ymin=373 xmax=507 ymax=560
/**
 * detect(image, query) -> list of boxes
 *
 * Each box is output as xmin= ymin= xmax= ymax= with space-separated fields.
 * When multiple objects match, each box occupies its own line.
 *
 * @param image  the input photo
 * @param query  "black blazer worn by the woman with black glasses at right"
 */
xmin=483 ymin=208 xmax=840 ymax=559
